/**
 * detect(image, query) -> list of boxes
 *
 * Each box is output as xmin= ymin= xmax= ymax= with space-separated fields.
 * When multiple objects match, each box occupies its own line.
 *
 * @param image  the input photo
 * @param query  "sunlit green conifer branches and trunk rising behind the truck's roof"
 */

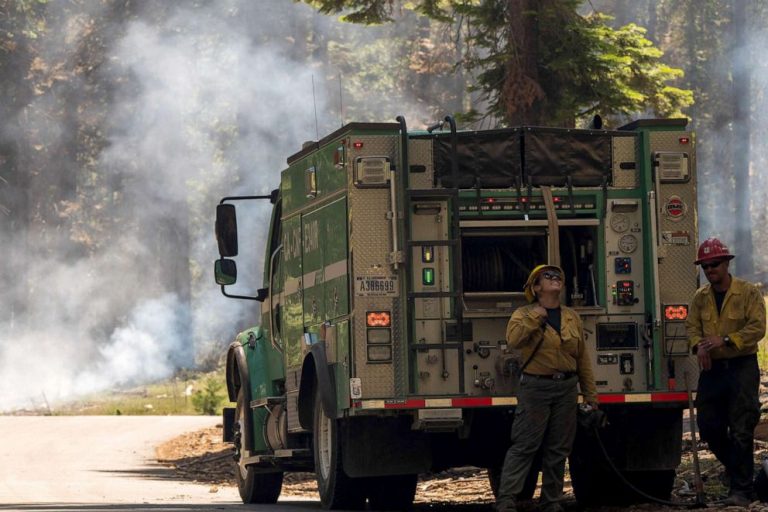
xmin=308 ymin=0 xmax=693 ymax=126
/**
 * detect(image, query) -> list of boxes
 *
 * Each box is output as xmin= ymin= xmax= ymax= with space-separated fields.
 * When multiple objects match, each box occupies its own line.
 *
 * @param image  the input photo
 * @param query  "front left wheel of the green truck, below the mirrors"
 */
xmin=234 ymin=389 xmax=283 ymax=503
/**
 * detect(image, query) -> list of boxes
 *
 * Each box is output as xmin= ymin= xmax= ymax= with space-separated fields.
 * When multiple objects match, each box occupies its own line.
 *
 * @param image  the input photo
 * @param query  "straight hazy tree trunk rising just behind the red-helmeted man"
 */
xmin=731 ymin=0 xmax=754 ymax=277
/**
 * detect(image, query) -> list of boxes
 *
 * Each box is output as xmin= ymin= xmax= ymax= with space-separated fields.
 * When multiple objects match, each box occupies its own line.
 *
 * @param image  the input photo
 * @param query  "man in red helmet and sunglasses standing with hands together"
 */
xmin=686 ymin=238 xmax=765 ymax=506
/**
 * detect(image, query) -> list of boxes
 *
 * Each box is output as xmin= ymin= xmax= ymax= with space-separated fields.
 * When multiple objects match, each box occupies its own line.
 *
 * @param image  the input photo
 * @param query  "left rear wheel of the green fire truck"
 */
xmin=313 ymin=389 xmax=365 ymax=510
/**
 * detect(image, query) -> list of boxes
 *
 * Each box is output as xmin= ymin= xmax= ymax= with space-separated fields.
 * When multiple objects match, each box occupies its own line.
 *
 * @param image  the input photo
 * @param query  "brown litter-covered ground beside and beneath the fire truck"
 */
xmin=157 ymin=422 xmax=768 ymax=512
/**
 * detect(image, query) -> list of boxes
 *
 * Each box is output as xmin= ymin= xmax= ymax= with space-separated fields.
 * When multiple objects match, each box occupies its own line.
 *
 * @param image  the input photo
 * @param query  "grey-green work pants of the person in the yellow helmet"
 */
xmin=497 ymin=375 xmax=578 ymax=509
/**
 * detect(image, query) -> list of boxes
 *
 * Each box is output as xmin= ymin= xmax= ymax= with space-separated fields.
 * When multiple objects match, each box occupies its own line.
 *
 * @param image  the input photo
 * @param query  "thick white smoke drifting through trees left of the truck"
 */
xmin=0 ymin=0 xmax=438 ymax=411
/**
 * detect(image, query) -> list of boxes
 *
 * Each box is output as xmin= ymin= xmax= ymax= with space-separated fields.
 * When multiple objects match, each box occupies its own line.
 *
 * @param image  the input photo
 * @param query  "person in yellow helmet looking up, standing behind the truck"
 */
xmin=496 ymin=265 xmax=597 ymax=512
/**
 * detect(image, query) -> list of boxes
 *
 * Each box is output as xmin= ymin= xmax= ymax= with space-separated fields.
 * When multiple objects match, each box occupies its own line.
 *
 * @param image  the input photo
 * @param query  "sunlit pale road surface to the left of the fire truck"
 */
xmin=0 ymin=416 xmax=319 ymax=512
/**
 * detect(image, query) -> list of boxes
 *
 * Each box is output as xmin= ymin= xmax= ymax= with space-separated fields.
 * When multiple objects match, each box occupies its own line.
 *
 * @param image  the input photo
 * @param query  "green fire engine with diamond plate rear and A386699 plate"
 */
xmin=215 ymin=117 xmax=698 ymax=510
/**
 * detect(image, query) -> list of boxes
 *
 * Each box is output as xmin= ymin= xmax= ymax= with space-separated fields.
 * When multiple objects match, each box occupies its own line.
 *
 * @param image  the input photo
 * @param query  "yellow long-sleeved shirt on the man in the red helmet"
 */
xmin=685 ymin=276 xmax=765 ymax=359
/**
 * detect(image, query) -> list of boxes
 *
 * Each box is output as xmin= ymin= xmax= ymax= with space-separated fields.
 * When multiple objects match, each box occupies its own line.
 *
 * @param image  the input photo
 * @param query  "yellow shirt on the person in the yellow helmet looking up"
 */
xmin=507 ymin=303 xmax=597 ymax=403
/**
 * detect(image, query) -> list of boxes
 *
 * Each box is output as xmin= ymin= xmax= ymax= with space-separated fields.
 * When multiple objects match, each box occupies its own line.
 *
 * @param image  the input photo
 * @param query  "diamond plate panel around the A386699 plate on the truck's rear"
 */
xmin=349 ymin=136 xmax=402 ymax=399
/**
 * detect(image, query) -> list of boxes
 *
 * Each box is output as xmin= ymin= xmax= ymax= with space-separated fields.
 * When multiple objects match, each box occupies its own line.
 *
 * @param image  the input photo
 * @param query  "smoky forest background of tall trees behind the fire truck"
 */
xmin=0 ymin=0 xmax=768 ymax=411
